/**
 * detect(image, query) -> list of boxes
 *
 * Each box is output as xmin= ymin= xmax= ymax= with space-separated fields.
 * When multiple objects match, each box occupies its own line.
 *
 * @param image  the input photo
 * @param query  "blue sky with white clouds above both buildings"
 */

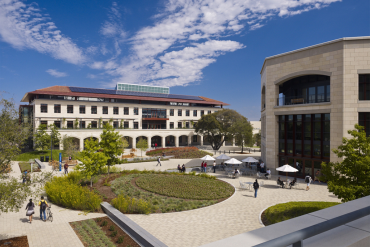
xmin=0 ymin=0 xmax=370 ymax=120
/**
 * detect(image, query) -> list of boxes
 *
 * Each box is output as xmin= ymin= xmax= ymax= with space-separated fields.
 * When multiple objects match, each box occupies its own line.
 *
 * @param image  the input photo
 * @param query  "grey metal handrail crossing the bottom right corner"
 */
xmin=255 ymin=206 xmax=370 ymax=247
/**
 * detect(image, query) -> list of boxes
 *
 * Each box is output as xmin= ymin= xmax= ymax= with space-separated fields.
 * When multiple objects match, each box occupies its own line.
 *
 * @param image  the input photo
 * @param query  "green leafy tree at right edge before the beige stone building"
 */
xmin=321 ymin=124 xmax=370 ymax=202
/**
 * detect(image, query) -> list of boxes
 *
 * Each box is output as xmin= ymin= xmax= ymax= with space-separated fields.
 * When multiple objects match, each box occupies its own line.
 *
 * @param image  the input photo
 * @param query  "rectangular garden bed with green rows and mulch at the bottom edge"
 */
xmin=70 ymin=217 xmax=139 ymax=247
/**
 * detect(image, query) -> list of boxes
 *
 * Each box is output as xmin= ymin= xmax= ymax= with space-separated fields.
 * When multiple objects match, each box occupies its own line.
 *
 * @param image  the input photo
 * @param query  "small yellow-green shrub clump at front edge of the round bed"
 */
xmin=111 ymin=195 xmax=151 ymax=214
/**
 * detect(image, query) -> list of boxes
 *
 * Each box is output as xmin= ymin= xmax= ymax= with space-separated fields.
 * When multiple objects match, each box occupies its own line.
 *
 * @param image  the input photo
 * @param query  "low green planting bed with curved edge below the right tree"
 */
xmin=261 ymin=202 xmax=340 ymax=226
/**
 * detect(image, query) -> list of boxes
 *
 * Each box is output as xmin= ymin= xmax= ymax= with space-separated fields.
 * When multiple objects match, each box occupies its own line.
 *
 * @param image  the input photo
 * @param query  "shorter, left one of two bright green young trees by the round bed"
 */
xmin=76 ymin=138 xmax=109 ymax=187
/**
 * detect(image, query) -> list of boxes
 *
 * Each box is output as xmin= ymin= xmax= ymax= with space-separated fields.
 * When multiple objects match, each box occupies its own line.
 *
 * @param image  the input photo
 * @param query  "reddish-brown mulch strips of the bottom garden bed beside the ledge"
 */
xmin=70 ymin=217 xmax=140 ymax=247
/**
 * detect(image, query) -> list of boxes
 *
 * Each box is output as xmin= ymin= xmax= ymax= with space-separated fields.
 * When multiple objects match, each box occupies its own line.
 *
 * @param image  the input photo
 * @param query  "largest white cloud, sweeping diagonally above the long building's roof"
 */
xmin=91 ymin=0 xmax=341 ymax=87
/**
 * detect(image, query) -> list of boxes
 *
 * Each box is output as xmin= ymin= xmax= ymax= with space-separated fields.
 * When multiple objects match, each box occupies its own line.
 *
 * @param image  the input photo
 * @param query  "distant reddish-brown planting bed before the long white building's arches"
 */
xmin=146 ymin=147 xmax=213 ymax=159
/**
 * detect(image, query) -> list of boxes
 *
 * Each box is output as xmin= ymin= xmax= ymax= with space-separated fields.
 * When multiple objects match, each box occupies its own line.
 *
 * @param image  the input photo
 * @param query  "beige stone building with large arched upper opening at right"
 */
xmin=261 ymin=37 xmax=370 ymax=177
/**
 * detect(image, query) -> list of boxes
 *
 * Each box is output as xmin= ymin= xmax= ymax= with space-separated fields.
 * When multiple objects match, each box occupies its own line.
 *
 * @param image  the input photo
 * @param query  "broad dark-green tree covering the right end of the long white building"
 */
xmin=195 ymin=109 xmax=242 ymax=150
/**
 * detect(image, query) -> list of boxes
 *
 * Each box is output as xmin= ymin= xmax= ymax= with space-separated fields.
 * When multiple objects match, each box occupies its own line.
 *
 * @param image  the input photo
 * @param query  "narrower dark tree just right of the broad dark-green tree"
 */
xmin=230 ymin=116 xmax=253 ymax=152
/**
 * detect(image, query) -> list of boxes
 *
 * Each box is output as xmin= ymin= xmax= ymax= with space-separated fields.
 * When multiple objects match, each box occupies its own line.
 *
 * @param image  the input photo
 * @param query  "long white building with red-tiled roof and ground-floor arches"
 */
xmin=20 ymin=84 xmax=233 ymax=150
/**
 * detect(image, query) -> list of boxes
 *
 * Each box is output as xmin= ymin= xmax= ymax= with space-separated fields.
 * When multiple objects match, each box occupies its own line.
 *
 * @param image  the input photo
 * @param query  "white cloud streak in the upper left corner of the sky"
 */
xmin=0 ymin=0 xmax=85 ymax=64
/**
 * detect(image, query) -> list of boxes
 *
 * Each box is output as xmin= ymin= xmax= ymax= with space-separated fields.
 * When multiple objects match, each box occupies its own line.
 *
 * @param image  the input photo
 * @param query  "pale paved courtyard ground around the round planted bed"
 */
xmin=0 ymin=153 xmax=340 ymax=247
